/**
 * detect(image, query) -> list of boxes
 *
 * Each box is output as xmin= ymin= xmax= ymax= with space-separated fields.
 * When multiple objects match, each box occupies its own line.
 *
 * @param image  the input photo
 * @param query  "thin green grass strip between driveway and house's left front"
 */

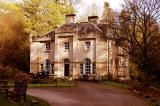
xmin=8 ymin=82 xmax=76 ymax=87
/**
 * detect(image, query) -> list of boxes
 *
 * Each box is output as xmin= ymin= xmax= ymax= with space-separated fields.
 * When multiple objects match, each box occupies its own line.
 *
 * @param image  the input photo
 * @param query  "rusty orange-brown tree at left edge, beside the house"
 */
xmin=0 ymin=12 xmax=29 ymax=72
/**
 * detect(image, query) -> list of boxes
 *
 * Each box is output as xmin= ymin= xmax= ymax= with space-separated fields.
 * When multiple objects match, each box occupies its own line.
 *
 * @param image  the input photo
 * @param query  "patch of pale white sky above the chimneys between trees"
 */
xmin=77 ymin=0 xmax=124 ymax=16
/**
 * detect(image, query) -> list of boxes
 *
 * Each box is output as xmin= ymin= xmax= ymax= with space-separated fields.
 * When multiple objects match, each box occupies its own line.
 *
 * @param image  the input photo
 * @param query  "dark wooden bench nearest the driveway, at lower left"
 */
xmin=8 ymin=82 xmax=27 ymax=102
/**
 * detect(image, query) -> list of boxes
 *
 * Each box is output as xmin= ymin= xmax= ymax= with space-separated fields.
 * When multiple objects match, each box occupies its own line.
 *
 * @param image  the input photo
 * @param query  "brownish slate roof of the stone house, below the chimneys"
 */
xmin=33 ymin=22 xmax=106 ymax=40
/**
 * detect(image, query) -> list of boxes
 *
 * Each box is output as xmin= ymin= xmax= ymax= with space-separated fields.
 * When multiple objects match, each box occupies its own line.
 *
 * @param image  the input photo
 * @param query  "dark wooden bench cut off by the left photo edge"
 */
xmin=0 ymin=80 xmax=9 ymax=96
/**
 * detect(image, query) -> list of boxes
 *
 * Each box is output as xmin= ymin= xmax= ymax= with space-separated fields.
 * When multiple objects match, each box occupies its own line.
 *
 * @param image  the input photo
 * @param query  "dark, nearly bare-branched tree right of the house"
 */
xmin=116 ymin=0 xmax=160 ymax=86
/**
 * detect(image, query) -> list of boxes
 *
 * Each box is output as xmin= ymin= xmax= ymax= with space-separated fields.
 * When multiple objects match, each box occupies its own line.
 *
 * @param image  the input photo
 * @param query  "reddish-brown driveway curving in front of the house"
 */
xmin=27 ymin=82 xmax=149 ymax=106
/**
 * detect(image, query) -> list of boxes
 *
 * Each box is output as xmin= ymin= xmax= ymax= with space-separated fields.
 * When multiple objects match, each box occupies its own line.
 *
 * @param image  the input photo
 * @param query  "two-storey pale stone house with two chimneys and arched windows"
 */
xmin=30 ymin=14 xmax=129 ymax=79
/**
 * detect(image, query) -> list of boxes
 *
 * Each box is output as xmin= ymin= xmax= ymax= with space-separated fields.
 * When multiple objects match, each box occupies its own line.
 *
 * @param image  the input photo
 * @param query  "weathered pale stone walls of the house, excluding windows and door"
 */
xmin=30 ymin=22 xmax=129 ymax=79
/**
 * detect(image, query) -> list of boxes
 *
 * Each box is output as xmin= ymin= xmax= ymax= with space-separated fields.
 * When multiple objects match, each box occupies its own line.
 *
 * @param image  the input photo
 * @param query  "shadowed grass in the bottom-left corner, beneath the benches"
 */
xmin=0 ymin=95 xmax=50 ymax=106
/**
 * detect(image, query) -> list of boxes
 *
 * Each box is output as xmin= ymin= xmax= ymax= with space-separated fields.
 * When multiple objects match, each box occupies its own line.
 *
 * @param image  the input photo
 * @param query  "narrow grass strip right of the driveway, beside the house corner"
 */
xmin=100 ymin=81 xmax=131 ymax=88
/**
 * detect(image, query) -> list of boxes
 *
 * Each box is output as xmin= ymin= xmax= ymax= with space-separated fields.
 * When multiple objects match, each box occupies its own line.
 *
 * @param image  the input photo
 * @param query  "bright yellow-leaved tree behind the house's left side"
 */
xmin=0 ymin=0 xmax=74 ymax=35
